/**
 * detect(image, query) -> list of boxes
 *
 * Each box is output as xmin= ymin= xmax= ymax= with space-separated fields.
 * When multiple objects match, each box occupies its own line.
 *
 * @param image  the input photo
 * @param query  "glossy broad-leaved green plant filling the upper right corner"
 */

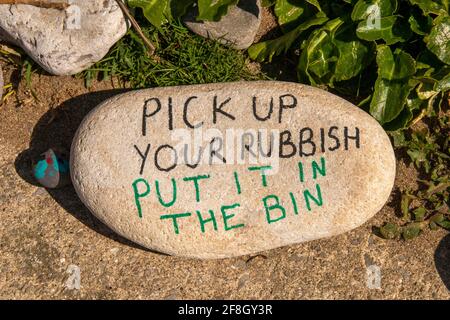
xmin=248 ymin=0 xmax=450 ymax=131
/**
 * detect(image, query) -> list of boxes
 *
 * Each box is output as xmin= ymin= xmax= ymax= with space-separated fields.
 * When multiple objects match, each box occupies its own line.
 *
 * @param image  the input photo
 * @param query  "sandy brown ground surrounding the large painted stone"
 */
xmin=0 ymin=7 xmax=450 ymax=299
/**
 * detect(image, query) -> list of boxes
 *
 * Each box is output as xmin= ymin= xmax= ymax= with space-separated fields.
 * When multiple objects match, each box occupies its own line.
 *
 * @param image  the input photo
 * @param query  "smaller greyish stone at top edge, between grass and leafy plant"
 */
xmin=184 ymin=0 xmax=262 ymax=49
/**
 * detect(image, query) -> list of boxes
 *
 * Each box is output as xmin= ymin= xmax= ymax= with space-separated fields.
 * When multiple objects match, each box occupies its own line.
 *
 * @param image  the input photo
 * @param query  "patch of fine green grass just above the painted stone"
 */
xmin=81 ymin=19 xmax=268 ymax=88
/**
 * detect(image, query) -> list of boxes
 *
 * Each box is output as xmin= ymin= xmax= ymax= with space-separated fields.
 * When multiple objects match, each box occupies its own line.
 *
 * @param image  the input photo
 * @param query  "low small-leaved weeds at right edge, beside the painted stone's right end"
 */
xmin=379 ymin=115 xmax=450 ymax=240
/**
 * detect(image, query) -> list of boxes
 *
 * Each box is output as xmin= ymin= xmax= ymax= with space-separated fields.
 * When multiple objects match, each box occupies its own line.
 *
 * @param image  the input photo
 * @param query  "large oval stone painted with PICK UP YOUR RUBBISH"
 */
xmin=70 ymin=81 xmax=395 ymax=259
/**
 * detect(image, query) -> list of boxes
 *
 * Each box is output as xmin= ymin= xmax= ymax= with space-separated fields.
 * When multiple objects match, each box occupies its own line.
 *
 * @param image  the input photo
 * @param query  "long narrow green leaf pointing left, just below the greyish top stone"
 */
xmin=248 ymin=17 xmax=328 ymax=62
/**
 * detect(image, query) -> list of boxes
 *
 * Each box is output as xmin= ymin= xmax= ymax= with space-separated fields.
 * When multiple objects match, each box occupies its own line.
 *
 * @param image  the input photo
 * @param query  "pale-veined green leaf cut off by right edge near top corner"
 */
xmin=425 ymin=16 xmax=450 ymax=64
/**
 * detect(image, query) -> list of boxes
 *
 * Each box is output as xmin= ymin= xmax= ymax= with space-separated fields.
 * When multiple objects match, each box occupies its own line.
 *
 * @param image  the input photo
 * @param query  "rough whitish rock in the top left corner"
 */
xmin=0 ymin=0 xmax=127 ymax=75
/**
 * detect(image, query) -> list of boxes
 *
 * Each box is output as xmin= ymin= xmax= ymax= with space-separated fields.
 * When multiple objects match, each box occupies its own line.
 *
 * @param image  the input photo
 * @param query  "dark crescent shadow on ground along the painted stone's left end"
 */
xmin=14 ymin=89 xmax=155 ymax=251
